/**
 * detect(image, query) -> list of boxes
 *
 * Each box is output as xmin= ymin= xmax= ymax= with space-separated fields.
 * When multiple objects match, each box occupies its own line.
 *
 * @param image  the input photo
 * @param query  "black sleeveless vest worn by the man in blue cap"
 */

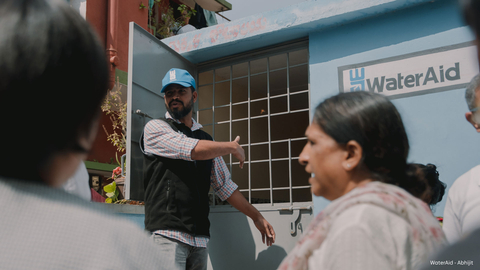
xmin=140 ymin=119 xmax=212 ymax=236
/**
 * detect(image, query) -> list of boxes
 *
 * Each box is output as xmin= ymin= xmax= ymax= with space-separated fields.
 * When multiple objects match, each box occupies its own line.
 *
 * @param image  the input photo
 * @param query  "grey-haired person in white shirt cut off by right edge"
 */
xmin=443 ymin=75 xmax=480 ymax=243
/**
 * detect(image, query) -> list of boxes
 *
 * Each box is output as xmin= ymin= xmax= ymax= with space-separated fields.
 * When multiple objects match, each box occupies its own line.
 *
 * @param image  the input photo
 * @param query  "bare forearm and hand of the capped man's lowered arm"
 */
xmin=227 ymin=189 xmax=275 ymax=246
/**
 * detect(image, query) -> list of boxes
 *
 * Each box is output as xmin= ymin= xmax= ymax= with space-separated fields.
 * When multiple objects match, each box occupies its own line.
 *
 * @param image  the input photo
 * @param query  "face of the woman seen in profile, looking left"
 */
xmin=299 ymin=123 xmax=348 ymax=200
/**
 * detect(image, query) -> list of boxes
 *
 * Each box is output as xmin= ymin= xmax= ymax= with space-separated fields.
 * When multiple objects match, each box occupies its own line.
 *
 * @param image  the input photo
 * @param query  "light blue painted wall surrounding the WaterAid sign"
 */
xmin=309 ymin=1 xmax=480 ymax=216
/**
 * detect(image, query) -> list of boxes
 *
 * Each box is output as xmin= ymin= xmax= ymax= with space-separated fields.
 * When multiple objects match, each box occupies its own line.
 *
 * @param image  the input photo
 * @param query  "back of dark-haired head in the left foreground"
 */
xmin=0 ymin=0 xmax=108 ymax=186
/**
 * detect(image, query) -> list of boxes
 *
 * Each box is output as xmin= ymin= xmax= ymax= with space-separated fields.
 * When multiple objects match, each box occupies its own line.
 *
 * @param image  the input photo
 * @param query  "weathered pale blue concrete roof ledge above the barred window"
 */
xmin=162 ymin=0 xmax=431 ymax=64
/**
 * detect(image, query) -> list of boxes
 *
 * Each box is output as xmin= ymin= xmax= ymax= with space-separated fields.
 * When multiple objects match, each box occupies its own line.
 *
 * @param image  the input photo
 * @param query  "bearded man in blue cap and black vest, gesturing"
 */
xmin=142 ymin=68 xmax=275 ymax=270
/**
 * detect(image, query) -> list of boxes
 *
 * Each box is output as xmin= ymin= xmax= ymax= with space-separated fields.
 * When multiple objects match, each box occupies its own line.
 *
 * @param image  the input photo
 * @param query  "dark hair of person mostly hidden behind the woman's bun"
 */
xmin=409 ymin=163 xmax=447 ymax=208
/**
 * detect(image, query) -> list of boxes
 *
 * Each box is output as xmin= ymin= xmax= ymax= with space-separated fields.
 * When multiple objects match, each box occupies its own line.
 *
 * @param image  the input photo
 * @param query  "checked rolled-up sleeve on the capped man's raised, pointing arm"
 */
xmin=144 ymin=120 xmax=198 ymax=161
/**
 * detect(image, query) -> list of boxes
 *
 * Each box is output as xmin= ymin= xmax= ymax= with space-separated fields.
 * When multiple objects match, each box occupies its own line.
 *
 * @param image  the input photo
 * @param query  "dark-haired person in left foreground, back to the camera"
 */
xmin=0 ymin=0 xmax=166 ymax=270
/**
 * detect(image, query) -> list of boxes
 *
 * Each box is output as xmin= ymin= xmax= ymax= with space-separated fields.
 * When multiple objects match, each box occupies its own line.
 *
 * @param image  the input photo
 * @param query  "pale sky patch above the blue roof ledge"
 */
xmin=217 ymin=0 xmax=307 ymax=24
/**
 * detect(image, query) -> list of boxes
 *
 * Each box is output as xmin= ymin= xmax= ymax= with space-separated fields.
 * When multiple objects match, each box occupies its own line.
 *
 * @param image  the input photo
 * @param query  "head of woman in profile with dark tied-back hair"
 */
xmin=300 ymin=92 xmax=428 ymax=200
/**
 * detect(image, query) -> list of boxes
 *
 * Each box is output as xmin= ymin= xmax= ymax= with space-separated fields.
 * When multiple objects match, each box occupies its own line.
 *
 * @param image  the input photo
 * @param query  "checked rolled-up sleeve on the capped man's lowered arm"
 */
xmin=210 ymin=157 xmax=238 ymax=201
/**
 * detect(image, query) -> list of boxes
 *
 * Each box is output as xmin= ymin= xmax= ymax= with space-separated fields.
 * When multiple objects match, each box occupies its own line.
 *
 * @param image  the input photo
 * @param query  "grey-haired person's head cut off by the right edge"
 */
xmin=465 ymin=74 xmax=480 ymax=132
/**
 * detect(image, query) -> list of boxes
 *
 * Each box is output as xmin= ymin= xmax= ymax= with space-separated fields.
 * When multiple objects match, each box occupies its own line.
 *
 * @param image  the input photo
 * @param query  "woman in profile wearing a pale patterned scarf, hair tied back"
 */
xmin=279 ymin=92 xmax=445 ymax=270
